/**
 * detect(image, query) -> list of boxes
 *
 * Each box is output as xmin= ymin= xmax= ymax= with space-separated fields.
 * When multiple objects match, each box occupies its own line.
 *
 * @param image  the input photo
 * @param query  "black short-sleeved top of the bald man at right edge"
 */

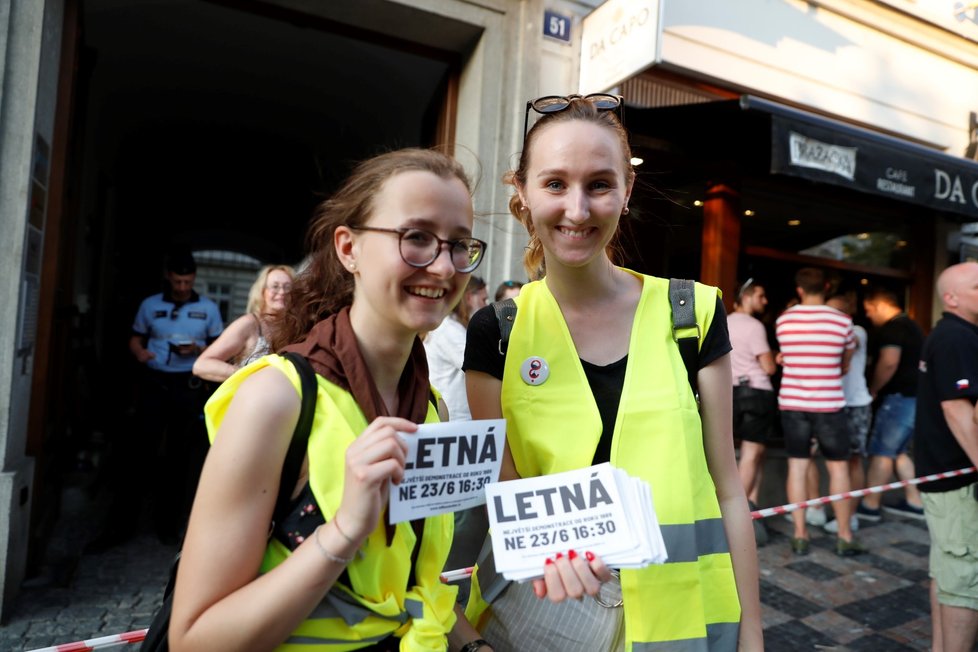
xmin=913 ymin=312 xmax=978 ymax=491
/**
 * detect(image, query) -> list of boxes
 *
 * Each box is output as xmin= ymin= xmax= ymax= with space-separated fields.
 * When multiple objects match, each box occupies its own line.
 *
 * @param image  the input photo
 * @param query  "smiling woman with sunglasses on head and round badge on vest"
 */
xmin=465 ymin=95 xmax=763 ymax=652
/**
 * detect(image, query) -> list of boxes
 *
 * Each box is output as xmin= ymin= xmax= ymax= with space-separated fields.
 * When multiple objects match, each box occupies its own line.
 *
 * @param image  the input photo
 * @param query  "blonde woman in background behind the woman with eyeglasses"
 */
xmin=194 ymin=265 xmax=295 ymax=383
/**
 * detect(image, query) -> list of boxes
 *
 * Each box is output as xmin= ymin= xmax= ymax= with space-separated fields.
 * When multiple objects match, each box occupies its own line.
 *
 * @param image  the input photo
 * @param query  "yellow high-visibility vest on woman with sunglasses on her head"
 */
xmin=468 ymin=270 xmax=740 ymax=652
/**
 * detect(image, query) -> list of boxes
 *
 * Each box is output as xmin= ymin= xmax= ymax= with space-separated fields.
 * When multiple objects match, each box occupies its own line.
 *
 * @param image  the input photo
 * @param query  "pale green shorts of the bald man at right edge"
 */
xmin=920 ymin=484 xmax=978 ymax=610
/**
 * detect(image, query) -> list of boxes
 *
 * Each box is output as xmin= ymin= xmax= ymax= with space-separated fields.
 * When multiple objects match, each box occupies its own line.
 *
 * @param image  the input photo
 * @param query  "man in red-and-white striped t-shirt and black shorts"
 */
xmin=775 ymin=267 xmax=865 ymax=556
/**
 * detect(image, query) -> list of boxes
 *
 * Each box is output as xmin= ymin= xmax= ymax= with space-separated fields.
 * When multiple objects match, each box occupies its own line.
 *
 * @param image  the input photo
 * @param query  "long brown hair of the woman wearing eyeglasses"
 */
xmin=271 ymin=149 xmax=472 ymax=351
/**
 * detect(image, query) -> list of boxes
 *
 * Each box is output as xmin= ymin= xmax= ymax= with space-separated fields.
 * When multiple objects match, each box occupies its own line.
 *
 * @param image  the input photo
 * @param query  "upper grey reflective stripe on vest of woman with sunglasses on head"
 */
xmin=478 ymin=518 xmax=730 ymax=604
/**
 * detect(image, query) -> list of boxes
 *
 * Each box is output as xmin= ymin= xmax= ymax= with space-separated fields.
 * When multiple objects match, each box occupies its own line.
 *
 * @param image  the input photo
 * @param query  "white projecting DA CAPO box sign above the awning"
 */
xmin=579 ymin=0 xmax=660 ymax=93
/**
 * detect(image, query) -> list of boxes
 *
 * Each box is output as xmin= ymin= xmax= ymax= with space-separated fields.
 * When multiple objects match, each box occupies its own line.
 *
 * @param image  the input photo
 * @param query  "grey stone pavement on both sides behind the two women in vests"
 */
xmin=0 ymin=476 xmax=978 ymax=652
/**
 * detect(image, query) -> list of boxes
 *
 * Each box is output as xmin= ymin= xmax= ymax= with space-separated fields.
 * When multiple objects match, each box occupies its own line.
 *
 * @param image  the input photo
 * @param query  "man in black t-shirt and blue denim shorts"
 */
xmin=856 ymin=288 xmax=924 ymax=521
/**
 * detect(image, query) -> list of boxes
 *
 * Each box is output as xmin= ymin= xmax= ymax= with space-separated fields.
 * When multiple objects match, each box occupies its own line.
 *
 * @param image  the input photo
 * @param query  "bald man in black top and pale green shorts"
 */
xmin=914 ymin=263 xmax=978 ymax=652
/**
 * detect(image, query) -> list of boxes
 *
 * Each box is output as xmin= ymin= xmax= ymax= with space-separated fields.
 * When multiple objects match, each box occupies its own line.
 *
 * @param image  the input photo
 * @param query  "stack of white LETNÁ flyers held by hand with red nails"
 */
xmin=486 ymin=463 xmax=666 ymax=580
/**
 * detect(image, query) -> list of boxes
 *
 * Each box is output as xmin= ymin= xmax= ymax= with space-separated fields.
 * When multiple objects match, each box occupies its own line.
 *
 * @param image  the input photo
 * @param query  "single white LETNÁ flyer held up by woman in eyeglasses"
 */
xmin=387 ymin=419 xmax=506 ymax=524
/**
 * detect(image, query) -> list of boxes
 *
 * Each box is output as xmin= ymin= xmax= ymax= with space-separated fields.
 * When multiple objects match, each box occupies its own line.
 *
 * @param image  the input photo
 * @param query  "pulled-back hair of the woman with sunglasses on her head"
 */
xmin=503 ymin=97 xmax=635 ymax=280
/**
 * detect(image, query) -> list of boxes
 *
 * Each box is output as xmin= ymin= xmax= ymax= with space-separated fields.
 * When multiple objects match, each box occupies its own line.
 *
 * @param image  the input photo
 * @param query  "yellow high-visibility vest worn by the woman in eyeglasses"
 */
xmin=204 ymin=355 xmax=458 ymax=652
